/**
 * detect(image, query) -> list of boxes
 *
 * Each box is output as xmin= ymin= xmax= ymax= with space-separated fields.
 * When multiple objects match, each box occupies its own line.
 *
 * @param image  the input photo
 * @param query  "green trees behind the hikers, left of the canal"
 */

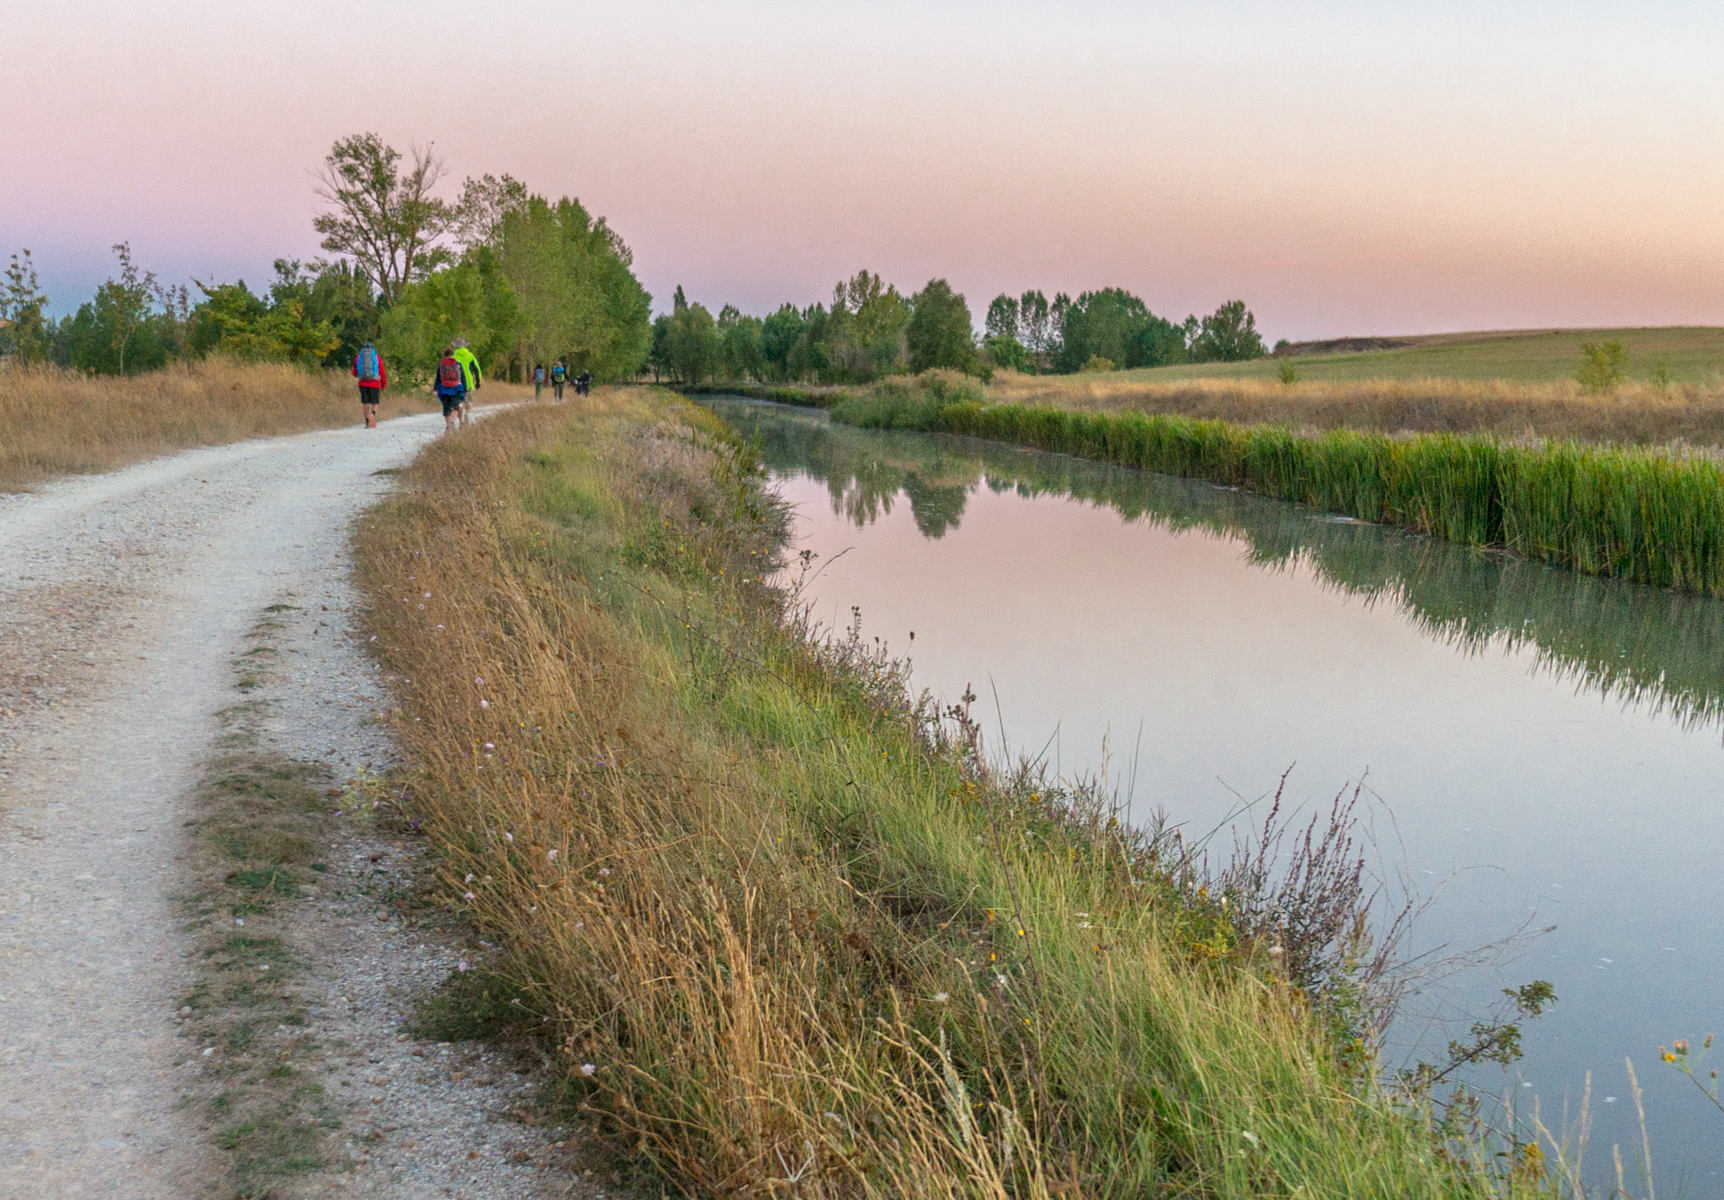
xmin=0 ymin=133 xmax=652 ymax=379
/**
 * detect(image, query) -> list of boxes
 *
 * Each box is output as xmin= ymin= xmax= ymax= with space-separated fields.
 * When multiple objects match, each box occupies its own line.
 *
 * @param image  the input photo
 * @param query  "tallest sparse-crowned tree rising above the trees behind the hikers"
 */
xmin=312 ymin=133 xmax=453 ymax=307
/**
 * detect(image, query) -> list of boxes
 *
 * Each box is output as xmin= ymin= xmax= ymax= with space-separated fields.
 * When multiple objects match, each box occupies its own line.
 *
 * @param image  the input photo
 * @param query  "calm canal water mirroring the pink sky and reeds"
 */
xmin=712 ymin=400 xmax=1724 ymax=1195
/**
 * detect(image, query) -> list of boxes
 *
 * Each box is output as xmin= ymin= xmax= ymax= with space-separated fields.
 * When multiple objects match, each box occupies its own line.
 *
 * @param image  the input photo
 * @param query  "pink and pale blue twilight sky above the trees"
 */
xmin=0 ymin=0 xmax=1724 ymax=340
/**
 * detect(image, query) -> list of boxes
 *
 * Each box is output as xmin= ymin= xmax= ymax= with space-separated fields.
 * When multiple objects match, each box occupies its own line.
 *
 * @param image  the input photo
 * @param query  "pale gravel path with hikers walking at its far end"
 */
xmin=0 ymin=416 xmax=596 ymax=1200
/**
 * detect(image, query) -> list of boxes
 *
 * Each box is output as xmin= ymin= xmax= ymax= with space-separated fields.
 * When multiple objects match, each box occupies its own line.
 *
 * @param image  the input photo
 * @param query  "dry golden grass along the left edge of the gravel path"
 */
xmin=0 ymin=357 xmax=526 ymax=491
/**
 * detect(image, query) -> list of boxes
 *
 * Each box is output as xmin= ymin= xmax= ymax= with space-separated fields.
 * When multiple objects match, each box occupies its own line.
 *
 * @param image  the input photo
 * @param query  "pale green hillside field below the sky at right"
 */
xmin=1109 ymin=326 xmax=1724 ymax=383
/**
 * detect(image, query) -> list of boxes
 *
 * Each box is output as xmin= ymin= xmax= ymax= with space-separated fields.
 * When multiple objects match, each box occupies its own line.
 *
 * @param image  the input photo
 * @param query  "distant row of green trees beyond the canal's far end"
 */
xmin=647 ymin=269 xmax=1265 ymax=383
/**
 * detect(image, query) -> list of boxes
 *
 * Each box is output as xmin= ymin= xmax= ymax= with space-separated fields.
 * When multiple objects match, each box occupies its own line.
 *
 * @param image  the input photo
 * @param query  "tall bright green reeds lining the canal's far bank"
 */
xmin=831 ymin=374 xmax=1724 ymax=595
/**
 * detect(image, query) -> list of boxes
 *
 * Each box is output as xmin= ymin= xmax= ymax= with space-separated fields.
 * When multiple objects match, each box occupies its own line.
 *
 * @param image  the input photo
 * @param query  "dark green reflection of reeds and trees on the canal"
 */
xmin=715 ymin=400 xmax=1724 ymax=729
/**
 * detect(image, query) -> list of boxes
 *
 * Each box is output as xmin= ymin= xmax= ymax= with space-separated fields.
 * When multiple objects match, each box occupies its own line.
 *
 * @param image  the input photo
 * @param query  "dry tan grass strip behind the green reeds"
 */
xmin=988 ymin=372 xmax=1724 ymax=447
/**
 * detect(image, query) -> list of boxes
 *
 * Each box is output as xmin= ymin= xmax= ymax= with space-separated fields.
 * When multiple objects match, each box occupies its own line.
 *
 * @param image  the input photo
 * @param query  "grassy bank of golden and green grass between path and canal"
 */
xmin=359 ymin=390 xmax=1522 ymax=1198
